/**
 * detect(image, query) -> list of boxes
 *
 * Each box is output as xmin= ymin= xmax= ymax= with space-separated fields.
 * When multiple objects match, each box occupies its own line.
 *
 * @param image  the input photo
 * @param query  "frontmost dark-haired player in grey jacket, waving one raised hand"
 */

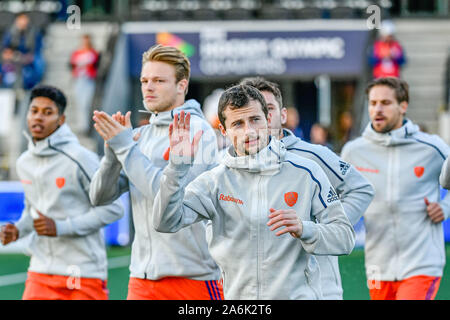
xmin=153 ymin=85 xmax=355 ymax=300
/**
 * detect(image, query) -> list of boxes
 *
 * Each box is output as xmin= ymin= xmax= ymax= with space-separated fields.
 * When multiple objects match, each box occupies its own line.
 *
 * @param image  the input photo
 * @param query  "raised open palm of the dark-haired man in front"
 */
xmin=169 ymin=111 xmax=203 ymax=159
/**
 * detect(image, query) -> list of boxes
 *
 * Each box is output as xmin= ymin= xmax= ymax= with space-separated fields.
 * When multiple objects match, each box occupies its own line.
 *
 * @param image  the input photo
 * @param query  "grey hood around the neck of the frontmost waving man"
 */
xmin=222 ymin=137 xmax=286 ymax=175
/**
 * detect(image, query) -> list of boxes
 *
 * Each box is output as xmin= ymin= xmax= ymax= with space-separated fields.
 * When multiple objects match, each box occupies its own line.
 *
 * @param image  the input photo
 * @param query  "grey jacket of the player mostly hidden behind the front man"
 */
xmin=281 ymin=129 xmax=375 ymax=300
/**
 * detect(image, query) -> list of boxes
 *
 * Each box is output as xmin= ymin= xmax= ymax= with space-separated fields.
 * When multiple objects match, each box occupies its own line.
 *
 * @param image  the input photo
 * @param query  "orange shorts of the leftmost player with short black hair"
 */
xmin=22 ymin=272 xmax=108 ymax=300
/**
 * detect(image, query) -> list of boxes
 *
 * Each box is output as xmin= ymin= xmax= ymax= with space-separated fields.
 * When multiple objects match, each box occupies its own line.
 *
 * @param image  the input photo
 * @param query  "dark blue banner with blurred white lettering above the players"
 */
xmin=125 ymin=23 xmax=369 ymax=77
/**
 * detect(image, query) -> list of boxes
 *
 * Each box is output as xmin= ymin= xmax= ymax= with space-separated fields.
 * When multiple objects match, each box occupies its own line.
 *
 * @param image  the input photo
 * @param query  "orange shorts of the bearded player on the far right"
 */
xmin=369 ymin=276 xmax=441 ymax=300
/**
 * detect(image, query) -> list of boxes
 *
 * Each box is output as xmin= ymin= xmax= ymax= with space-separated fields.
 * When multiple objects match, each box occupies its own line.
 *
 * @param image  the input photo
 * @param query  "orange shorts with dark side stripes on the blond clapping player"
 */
xmin=127 ymin=277 xmax=223 ymax=300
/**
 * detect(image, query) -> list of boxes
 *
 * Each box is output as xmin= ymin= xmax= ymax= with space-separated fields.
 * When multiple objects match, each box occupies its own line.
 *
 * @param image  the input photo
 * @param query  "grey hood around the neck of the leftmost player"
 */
xmin=24 ymin=123 xmax=78 ymax=157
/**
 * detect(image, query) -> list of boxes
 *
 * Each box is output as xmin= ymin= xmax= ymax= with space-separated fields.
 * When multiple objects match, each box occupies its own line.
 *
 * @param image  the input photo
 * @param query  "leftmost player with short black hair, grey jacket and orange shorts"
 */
xmin=0 ymin=85 xmax=123 ymax=300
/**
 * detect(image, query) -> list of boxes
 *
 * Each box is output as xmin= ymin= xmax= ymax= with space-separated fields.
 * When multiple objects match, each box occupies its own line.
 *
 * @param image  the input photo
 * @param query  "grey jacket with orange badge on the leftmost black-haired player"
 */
xmin=16 ymin=124 xmax=123 ymax=280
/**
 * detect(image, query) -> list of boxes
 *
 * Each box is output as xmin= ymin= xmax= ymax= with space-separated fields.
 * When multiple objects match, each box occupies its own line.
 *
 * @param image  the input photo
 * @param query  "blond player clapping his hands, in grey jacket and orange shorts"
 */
xmin=90 ymin=45 xmax=223 ymax=300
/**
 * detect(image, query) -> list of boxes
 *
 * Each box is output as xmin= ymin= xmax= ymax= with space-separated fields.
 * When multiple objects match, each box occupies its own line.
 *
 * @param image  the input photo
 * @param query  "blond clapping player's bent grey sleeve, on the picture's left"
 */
xmin=89 ymin=145 xmax=129 ymax=206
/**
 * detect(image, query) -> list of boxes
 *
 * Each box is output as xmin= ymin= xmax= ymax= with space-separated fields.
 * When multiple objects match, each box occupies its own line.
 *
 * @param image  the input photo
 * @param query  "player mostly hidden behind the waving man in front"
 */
xmin=241 ymin=77 xmax=374 ymax=300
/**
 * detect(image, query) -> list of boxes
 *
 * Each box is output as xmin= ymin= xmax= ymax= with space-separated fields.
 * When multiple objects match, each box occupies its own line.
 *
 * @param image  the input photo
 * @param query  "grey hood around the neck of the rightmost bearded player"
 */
xmin=362 ymin=119 xmax=419 ymax=146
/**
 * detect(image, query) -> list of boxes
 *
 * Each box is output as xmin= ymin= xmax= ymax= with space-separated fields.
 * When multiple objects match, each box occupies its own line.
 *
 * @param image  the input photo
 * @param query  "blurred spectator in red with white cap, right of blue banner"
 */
xmin=370 ymin=20 xmax=406 ymax=79
